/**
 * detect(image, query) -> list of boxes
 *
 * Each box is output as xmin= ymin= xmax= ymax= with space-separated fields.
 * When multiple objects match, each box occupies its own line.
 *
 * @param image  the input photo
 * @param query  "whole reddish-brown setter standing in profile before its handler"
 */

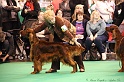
xmin=20 ymin=28 xmax=85 ymax=74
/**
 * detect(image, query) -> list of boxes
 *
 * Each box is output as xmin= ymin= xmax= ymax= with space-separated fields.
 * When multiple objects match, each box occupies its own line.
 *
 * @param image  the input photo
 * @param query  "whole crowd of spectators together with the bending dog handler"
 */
xmin=0 ymin=0 xmax=124 ymax=73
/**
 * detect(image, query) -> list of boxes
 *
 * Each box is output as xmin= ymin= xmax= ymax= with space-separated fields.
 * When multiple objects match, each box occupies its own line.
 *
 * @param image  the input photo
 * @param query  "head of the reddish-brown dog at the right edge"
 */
xmin=106 ymin=25 xmax=120 ymax=39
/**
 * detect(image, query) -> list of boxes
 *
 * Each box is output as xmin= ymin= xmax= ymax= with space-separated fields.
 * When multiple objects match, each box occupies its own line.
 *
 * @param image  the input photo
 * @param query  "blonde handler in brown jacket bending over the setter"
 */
xmin=29 ymin=10 xmax=81 ymax=73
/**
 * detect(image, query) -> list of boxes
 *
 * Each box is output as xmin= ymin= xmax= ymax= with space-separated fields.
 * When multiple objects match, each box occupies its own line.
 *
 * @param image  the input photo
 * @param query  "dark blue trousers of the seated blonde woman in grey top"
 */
xmin=85 ymin=35 xmax=108 ymax=53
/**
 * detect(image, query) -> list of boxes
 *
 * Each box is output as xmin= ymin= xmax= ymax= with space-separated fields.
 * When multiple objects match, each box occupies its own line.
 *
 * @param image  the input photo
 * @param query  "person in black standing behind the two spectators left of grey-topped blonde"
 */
xmin=69 ymin=0 xmax=90 ymax=21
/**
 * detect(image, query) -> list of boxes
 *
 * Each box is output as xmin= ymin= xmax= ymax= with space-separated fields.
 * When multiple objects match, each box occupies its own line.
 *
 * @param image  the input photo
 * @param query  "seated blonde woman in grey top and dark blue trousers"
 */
xmin=85 ymin=10 xmax=108 ymax=60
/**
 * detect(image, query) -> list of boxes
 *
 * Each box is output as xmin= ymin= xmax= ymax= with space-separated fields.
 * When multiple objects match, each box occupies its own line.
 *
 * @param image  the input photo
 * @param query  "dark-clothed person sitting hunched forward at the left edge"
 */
xmin=0 ymin=27 xmax=14 ymax=62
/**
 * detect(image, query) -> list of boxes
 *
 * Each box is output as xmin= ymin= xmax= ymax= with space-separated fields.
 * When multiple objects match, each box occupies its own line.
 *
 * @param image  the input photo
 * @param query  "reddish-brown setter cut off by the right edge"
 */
xmin=106 ymin=25 xmax=124 ymax=72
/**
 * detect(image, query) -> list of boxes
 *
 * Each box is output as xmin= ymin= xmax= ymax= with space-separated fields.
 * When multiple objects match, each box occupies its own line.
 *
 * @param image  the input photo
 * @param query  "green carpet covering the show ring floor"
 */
xmin=0 ymin=61 xmax=124 ymax=82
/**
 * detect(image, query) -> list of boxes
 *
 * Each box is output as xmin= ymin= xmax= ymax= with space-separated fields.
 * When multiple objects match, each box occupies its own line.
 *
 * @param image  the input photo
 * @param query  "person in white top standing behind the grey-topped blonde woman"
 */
xmin=96 ymin=0 xmax=115 ymax=26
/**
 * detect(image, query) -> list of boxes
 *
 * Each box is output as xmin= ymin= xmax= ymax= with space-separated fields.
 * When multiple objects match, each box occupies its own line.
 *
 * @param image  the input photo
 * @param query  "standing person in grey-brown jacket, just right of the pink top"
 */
xmin=59 ymin=0 xmax=71 ymax=21
